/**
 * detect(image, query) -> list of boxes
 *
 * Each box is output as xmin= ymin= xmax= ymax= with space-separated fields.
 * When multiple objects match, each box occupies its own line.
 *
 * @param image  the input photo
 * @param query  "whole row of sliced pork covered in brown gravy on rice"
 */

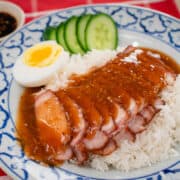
xmin=17 ymin=46 xmax=180 ymax=169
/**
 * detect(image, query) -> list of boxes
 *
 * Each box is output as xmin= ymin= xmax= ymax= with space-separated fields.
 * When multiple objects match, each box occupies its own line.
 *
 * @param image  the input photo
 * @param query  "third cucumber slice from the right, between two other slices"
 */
xmin=64 ymin=16 xmax=84 ymax=54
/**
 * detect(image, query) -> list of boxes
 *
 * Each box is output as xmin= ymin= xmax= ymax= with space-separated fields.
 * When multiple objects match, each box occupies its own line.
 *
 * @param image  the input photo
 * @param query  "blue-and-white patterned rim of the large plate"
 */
xmin=0 ymin=5 xmax=180 ymax=180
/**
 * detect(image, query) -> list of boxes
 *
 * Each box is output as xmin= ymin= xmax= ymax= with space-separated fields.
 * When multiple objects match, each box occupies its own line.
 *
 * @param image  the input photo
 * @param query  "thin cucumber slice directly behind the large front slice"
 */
xmin=77 ymin=14 xmax=93 ymax=51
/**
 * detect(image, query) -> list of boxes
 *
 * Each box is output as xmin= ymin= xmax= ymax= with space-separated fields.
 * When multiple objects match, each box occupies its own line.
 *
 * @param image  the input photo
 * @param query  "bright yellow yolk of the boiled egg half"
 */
xmin=23 ymin=44 xmax=62 ymax=67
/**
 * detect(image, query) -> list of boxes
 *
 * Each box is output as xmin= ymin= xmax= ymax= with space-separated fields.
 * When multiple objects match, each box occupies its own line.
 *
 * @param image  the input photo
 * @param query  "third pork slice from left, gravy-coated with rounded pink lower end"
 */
xmin=67 ymin=87 xmax=108 ymax=150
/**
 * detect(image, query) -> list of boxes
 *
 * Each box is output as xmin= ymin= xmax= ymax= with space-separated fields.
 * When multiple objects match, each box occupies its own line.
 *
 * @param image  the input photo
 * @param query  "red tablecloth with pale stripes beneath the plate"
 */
xmin=0 ymin=0 xmax=180 ymax=180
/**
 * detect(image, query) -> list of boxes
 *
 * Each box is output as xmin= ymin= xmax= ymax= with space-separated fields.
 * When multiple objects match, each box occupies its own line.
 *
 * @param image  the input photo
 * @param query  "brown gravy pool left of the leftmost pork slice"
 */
xmin=16 ymin=88 xmax=65 ymax=165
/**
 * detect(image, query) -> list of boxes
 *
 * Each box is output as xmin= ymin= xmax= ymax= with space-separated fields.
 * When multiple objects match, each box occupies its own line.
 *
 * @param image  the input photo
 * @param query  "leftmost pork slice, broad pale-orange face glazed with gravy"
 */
xmin=35 ymin=90 xmax=71 ymax=144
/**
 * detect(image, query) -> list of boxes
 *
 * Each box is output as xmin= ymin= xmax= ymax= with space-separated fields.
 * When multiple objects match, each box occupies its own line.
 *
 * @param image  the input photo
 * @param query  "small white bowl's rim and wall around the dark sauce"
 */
xmin=0 ymin=1 xmax=25 ymax=42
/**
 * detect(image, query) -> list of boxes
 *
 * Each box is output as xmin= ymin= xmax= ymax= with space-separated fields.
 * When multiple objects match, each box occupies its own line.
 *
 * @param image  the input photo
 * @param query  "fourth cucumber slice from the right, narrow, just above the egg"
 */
xmin=56 ymin=22 xmax=69 ymax=51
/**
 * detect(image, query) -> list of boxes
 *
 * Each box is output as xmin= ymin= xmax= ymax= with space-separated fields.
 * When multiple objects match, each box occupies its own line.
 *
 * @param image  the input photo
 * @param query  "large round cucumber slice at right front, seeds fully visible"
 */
xmin=85 ymin=13 xmax=118 ymax=50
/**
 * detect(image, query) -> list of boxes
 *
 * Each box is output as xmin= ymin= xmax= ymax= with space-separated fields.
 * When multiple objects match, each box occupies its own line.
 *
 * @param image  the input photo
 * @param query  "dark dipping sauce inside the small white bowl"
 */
xmin=0 ymin=12 xmax=17 ymax=38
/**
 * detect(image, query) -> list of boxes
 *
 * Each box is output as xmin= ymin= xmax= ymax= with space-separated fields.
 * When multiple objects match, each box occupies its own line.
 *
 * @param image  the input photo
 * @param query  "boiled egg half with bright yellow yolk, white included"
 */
xmin=13 ymin=41 xmax=69 ymax=87
